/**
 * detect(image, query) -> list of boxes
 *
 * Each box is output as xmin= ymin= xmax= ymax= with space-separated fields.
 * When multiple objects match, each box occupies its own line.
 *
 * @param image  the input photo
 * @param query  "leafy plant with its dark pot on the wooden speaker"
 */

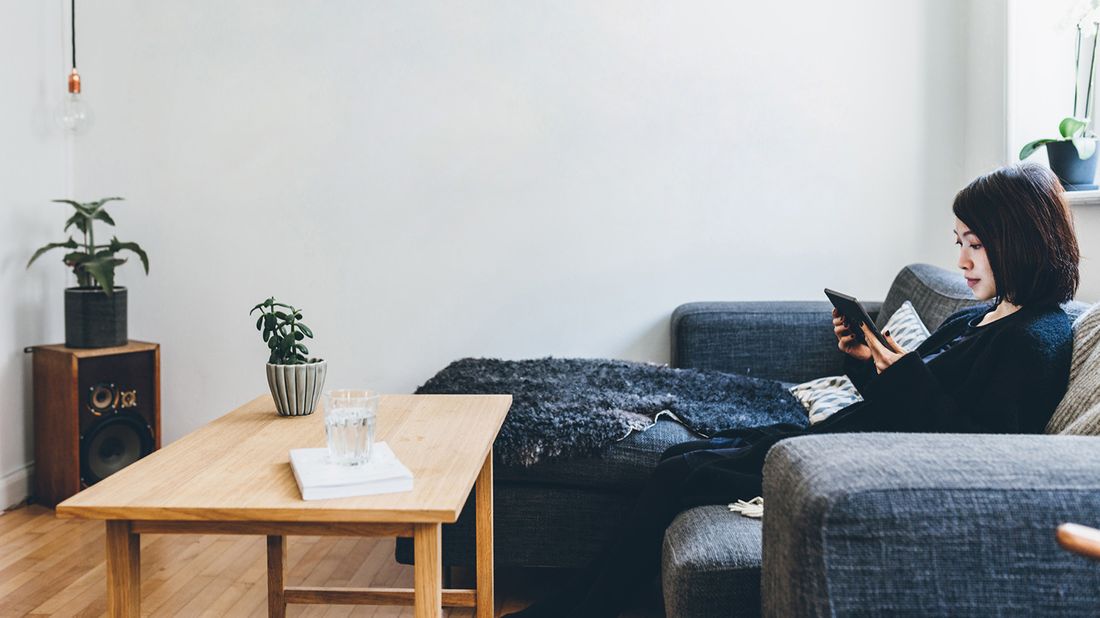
xmin=26 ymin=198 xmax=149 ymax=347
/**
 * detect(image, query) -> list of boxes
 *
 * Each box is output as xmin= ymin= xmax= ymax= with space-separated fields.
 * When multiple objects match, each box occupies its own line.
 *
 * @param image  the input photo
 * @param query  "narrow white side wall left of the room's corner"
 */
xmin=0 ymin=0 xmax=70 ymax=509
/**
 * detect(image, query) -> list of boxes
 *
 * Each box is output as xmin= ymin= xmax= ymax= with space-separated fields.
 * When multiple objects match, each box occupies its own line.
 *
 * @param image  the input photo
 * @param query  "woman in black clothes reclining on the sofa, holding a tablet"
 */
xmin=513 ymin=165 xmax=1079 ymax=618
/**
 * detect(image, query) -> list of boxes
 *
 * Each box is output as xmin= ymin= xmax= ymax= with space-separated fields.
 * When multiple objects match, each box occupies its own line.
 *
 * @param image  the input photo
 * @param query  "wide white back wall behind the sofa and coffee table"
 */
xmin=62 ymin=0 xmax=981 ymax=440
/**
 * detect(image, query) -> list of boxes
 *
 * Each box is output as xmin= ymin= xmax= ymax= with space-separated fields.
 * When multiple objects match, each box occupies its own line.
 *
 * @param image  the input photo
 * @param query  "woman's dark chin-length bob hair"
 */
xmin=952 ymin=164 xmax=1080 ymax=307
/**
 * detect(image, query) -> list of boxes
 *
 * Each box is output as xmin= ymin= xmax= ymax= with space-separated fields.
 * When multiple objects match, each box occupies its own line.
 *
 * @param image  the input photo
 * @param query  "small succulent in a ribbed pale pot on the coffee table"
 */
xmin=249 ymin=297 xmax=328 ymax=417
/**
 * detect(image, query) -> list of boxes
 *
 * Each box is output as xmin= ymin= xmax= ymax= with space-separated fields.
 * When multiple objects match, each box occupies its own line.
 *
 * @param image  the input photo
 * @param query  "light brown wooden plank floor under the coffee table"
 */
xmin=0 ymin=506 xmax=662 ymax=618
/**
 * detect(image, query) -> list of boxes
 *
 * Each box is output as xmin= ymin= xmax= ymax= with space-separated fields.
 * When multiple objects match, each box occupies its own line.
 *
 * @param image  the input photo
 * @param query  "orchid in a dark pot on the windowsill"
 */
xmin=1020 ymin=22 xmax=1100 ymax=191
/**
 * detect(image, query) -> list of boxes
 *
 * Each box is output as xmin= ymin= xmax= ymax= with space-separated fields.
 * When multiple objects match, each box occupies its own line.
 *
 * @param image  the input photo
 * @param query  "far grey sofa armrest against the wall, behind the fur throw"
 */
xmin=670 ymin=300 xmax=881 ymax=382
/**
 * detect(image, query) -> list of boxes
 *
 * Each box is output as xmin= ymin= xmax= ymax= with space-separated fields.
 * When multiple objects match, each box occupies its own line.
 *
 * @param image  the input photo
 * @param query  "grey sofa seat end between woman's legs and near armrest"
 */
xmin=661 ymin=506 xmax=760 ymax=618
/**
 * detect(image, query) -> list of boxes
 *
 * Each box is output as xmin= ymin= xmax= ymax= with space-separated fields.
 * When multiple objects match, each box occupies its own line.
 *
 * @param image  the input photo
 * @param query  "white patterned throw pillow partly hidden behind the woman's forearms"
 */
xmin=791 ymin=300 xmax=928 ymax=424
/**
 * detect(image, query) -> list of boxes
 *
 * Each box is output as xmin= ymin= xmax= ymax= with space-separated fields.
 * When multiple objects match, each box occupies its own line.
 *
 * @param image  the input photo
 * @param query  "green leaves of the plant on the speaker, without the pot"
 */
xmin=26 ymin=198 xmax=149 ymax=296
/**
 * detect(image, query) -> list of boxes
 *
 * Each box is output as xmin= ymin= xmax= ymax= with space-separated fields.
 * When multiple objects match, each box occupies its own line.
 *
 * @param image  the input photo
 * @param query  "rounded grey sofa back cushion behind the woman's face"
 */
xmin=875 ymin=264 xmax=1089 ymax=331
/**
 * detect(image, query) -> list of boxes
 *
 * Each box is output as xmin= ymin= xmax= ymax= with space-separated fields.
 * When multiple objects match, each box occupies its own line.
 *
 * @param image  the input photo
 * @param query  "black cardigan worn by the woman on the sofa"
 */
xmin=810 ymin=305 xmax=1073 ymax=433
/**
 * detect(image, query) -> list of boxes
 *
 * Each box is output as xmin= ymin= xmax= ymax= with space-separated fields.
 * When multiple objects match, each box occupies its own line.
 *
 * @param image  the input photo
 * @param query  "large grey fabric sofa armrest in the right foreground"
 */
xmin=761 ymin=433 xmax=1100 ymax=617
